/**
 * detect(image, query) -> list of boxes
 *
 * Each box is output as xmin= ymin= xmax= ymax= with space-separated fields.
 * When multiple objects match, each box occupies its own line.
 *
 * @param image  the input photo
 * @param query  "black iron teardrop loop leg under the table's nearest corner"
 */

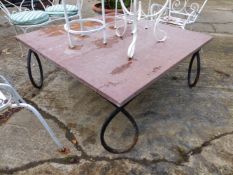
xmin=100 ymin=107 xmax=139 ymax=154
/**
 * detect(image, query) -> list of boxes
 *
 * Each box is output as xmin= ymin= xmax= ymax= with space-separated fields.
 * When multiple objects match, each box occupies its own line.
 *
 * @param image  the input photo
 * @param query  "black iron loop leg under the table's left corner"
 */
xmin=27 ymin=49 xmax=44 ymax=89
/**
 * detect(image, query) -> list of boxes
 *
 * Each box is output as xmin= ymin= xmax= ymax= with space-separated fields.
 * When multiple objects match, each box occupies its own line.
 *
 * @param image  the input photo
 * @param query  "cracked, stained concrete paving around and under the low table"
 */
xmin=0 ymin=0 xmax=233 ymax=175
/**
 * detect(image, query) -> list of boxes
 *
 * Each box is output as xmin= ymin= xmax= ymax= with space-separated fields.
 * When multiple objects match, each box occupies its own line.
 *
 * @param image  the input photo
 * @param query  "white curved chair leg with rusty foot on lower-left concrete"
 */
xmin=18 ymin=103 xmax=64 ymax=150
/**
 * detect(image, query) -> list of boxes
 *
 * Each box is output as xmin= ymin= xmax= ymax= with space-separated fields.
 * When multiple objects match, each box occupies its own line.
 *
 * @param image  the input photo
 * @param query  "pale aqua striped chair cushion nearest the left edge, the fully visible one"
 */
xmin=10 ymin=10 xmax=49 ymax=25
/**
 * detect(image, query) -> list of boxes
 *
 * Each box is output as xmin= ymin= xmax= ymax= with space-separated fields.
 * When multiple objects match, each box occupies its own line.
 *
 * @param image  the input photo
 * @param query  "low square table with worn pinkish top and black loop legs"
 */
xmin=17 ymin=19 xmax=212 ymax=154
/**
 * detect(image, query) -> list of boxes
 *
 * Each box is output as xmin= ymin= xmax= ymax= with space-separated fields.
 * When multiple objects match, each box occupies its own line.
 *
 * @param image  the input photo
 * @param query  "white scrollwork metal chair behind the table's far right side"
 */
xmin=152 ymin=0 xmax=208 ymax=29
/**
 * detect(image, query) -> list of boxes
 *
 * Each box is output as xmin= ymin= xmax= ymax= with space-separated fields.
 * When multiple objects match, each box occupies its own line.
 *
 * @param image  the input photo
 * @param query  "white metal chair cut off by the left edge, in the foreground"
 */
xmin=0 ymin=75 xmax=64 ymax=151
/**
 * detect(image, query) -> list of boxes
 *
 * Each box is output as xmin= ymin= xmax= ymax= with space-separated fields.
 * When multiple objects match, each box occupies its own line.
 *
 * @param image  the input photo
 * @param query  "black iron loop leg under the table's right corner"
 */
xmin=188 ymin=51 xmax=201 ymax=88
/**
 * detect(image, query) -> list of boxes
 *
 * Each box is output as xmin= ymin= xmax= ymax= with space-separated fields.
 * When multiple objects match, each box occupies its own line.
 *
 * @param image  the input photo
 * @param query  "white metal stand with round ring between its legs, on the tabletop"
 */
xmin=62 ymin=0 xmax=107 ymax=48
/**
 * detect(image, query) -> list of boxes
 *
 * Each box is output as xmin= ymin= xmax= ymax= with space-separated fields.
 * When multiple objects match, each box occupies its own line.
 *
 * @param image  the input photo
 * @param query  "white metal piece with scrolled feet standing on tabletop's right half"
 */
xmin=115 ymin=0 xmax=169 ymax=58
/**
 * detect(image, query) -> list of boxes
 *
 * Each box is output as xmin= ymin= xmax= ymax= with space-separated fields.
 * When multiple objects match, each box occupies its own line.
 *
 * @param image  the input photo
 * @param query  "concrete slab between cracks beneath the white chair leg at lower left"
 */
xmin=0 ymin=110 xmax=81 ymax=169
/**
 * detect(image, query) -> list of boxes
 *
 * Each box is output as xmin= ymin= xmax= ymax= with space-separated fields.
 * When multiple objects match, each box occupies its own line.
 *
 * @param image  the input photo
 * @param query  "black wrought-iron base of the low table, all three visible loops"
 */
xmin=27 ymin=49 xmax=201 ymax=154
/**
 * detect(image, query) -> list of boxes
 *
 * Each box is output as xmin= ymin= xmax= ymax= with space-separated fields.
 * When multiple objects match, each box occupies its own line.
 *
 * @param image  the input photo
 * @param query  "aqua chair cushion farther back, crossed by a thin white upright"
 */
xmin=45 ymin=4 xmax=78 ymax=17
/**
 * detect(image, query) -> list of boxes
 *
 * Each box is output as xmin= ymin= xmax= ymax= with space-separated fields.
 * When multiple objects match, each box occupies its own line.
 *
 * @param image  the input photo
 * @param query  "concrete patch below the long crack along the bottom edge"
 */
xmin=17 ymin=160 xmax=150 ymax=175
